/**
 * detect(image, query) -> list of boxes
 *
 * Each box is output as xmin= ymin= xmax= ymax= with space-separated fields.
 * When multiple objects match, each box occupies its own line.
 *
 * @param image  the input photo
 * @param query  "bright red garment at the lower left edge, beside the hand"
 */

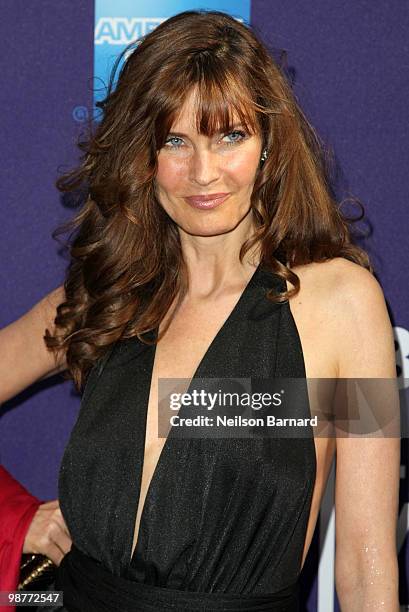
xmin=0 ymin=465 xmax=45 ymax=612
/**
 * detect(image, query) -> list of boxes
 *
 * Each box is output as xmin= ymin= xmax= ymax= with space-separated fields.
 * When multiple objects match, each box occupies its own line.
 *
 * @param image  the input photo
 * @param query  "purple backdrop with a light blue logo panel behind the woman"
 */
xmin=0 ymin=0 xmax=409 ymax=612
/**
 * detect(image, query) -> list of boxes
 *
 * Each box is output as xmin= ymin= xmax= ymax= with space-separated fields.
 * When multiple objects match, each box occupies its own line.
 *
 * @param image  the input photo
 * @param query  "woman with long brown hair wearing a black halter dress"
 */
xmin=1 ymin=11 xmax=399 ymax=612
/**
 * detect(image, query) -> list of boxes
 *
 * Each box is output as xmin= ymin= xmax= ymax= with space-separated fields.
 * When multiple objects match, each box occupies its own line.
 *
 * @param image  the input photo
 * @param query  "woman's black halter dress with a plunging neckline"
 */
xmin=59 ymin=264 xmax=316 ymax=612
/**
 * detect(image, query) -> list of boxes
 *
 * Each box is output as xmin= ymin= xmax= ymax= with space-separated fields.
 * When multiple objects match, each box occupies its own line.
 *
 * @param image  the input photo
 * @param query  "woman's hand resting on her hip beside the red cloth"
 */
xmin=23 ymin=499 xmax=72 ymax=565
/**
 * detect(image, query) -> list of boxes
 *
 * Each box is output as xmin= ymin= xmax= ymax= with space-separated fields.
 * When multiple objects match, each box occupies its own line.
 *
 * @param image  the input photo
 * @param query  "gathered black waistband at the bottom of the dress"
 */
xmin=56 ymin=544 xmax=299 ymax=612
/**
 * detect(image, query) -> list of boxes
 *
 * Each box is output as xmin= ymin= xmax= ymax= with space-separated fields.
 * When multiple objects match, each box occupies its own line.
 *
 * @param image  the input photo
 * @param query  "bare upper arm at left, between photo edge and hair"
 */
xmin=0 ymin=285 xmax=67 ymax=404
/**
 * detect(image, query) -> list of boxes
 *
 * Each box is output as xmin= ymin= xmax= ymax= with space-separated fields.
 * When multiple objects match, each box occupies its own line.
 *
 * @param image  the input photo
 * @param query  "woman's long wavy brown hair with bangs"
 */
xmin=44 ymin=10 xmax=373 ymax=390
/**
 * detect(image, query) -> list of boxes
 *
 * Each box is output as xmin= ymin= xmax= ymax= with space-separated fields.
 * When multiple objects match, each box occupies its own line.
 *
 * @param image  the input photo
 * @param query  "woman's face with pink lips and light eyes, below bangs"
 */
xmin=155 ymin=91 xmax=262 ymax=236
